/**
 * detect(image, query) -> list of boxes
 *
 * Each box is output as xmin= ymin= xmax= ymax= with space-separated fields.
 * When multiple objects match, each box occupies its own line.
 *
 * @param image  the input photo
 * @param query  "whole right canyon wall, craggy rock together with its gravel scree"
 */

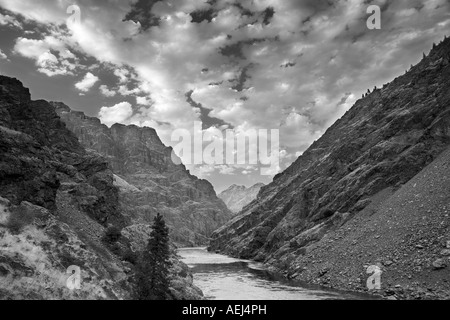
xmin=211 ymin=39 xmax=450 ymax=298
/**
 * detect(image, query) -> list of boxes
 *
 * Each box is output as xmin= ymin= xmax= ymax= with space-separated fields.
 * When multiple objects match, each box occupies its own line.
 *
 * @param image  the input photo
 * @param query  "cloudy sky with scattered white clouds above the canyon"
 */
xmin=0 ymin=0 xmax=450 ymax=192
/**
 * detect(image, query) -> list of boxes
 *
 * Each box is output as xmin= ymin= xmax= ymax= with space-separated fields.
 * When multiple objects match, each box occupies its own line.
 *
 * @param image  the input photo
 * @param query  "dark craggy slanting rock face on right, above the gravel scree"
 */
xmin=211 ymin=39 xmax=450 ymax=298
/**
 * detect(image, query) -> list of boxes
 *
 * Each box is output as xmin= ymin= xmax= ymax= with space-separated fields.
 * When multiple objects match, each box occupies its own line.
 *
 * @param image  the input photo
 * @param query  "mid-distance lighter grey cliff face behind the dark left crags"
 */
xmin=52 ymin=102 xmax=231 ymax=246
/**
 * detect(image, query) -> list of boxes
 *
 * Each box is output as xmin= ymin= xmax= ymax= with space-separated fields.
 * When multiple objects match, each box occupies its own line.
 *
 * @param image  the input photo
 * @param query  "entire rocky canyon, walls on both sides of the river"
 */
xmin=0 ymin=39 xmax=450 ymax=299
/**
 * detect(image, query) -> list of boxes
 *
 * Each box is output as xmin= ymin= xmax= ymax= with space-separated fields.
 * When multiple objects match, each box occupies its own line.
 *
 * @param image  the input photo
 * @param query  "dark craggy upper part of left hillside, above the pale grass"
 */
xmin=0 ymin=77 xmax=125 ymax=226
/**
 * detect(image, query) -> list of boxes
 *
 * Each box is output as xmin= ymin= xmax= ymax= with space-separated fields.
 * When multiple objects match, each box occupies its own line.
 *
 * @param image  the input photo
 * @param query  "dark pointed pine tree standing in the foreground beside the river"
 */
xmin=137 ymin=213 xmax=172 ymax=300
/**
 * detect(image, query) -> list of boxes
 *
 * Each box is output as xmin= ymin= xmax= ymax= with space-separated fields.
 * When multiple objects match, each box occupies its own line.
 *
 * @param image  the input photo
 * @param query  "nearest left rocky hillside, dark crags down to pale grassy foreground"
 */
xmin=0 ymin=76 xmax=201 ymax=299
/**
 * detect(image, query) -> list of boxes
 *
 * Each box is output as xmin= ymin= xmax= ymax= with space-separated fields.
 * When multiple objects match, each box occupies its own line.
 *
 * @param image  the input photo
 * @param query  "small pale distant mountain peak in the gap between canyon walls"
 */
xmin=219 ymin=183 xmax=264 ymax=213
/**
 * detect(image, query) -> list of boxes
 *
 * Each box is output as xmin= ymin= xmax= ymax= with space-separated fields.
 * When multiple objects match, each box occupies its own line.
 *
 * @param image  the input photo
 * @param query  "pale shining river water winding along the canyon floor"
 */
xmin=178 ymin=248 xmax=371 ymax=300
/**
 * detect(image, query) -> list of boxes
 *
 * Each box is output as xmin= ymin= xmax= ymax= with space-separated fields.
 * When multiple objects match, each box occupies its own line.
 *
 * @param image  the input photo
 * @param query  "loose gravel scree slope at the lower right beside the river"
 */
xmin=281 ymin=149 xmax=450 ymax=299
